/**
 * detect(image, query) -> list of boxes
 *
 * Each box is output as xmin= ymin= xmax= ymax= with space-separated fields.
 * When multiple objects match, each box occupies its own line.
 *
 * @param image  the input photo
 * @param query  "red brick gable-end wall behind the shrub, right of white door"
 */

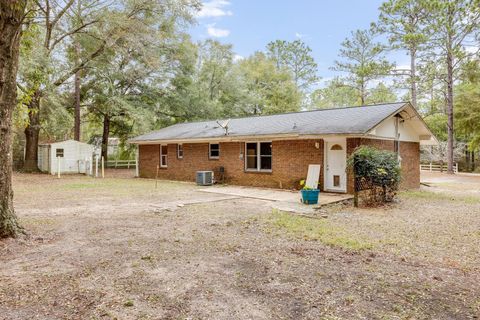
xmin=347 ymin=138 xmax=420 ymax=193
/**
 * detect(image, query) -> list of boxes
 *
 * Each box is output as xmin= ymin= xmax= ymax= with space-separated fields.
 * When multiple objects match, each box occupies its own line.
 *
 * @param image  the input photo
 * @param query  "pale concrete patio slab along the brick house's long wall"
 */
xmin=200 ymin=185 xmax=353 ymax=213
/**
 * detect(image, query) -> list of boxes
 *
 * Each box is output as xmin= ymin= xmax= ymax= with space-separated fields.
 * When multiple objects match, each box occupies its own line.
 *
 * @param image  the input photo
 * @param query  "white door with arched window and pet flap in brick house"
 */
xmin=324 ymin=139 xmax=347 ymax=192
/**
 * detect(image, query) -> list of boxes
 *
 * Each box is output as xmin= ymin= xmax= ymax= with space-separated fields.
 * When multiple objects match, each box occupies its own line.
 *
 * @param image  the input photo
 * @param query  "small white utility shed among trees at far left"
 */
xmin=38 ymin=140 xmax=95 ymax=174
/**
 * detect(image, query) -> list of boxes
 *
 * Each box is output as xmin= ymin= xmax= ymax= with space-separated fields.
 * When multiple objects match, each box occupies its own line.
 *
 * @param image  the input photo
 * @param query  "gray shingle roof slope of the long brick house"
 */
xmin=130 ymin=102 xmax=406 ymax=143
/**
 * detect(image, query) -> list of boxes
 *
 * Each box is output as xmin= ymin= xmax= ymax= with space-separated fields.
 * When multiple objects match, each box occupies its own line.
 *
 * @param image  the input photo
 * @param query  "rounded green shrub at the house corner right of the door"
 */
xmin=347 ymin=146 xmax=401 ymax=205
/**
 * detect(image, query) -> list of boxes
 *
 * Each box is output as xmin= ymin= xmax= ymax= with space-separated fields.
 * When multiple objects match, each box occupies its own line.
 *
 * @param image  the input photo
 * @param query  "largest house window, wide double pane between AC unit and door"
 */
xmin=245 ymin=142 xmax=272 ymax=171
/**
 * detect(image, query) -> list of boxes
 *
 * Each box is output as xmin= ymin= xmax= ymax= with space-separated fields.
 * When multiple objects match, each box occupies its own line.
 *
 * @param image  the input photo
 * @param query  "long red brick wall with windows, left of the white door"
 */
xmin=139 ymin=140 xmax=323 ymax=189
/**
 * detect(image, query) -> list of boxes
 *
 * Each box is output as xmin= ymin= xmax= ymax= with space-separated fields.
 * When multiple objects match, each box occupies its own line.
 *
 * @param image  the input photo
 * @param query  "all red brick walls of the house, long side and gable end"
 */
xmin=139 ymin=138 xmax=420 ymax=193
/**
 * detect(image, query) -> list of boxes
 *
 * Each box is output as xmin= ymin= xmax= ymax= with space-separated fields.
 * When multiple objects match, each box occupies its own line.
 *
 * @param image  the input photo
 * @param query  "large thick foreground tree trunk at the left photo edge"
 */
xmin=0 ymin=1 xmax=25 ymax=238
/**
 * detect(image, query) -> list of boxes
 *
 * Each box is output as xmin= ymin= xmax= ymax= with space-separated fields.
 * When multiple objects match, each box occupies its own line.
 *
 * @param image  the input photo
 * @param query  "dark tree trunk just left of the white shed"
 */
xmin=23 ymin=90 xmax=41 ymax=172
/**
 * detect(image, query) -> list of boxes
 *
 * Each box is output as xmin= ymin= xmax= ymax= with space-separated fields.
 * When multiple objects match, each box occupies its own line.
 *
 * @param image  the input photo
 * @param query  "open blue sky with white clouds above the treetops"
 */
xmin=191 ymin=0 xmax=408 ymax=86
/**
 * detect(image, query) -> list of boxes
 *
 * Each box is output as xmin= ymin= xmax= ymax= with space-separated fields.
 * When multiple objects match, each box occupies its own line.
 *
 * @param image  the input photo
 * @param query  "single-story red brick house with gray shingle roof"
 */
xmin=130 ymin=102 xmax=437 ymax=193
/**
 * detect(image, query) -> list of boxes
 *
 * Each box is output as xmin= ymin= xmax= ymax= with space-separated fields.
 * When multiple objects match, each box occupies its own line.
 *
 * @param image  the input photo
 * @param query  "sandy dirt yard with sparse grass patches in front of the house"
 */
xmin=0 ymin=170 xmax=480 ymax=320
